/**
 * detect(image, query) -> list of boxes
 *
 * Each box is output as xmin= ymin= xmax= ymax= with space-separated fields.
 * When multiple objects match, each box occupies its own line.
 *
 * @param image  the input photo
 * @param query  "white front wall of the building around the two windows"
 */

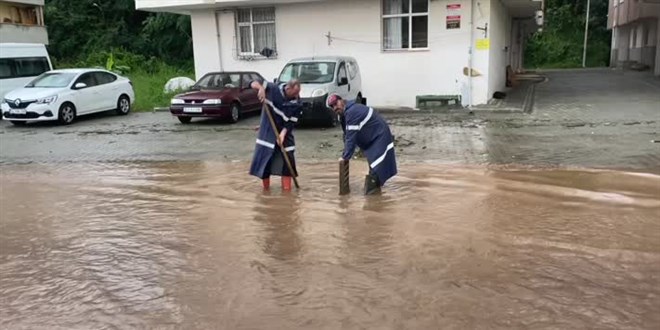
xmin=192 ymin=0 xmax=496 ymax=106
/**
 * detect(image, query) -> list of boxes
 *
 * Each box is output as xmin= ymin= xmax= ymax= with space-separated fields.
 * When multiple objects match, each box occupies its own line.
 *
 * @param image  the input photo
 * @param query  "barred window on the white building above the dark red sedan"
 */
xmin=236 ymin=8 xmax=277 ymax=55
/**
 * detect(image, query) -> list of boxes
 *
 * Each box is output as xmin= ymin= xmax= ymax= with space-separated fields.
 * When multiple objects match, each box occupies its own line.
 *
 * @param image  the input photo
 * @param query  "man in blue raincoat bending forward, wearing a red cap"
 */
xmin=326 ymin=94 xmax=397 ymax=195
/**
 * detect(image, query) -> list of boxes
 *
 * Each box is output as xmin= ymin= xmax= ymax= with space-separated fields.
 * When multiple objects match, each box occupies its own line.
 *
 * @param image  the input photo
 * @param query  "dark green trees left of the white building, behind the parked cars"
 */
xmin=45 ymin=0 xmax=192 ymax=65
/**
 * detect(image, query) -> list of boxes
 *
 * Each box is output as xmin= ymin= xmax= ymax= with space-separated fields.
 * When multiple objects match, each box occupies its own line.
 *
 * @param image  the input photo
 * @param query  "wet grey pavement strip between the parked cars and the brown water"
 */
xmin=0 ymin=69 xmax=660 ymax=173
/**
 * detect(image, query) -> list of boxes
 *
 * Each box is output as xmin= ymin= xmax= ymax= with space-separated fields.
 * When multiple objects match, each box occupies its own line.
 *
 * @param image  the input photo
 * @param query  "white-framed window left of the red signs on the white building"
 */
xmin=382 ymin=0 xmax=429 ymax=50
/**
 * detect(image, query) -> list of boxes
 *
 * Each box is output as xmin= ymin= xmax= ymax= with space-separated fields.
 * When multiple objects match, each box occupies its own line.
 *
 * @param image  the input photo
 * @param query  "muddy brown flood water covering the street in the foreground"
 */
xmin=0 ymin=162 xmax=660 ymax=329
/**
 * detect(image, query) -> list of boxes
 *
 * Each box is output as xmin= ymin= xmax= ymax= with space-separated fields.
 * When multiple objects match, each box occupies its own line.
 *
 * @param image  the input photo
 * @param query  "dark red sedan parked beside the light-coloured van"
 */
xmin=170 ymin=72 xmax=263 ymax=124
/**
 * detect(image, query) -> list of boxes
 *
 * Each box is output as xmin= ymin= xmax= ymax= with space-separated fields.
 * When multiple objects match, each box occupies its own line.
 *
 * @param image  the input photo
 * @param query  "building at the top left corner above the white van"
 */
xmin=0 ymin=0 xmax=48 ymax=45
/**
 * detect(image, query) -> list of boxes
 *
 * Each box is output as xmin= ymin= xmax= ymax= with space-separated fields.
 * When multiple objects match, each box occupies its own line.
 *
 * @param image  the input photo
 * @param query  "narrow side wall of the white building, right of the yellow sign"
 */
xmin=488 ymin=0 xmax=511 ymax=97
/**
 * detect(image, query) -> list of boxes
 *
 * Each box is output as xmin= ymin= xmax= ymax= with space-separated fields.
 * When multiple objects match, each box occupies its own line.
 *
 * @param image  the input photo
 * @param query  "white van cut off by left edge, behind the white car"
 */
xmin=0 ymin=43 xmax=53 ymax=99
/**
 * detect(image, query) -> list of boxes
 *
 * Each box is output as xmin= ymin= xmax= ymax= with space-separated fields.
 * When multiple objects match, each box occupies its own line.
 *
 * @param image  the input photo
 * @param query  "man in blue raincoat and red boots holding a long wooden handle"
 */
xmin=250 ymin=80 xmax=302 ymax=190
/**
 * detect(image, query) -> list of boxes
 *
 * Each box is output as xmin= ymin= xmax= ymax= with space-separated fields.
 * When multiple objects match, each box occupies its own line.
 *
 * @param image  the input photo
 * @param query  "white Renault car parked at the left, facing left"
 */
xmin=0 ymin=69 xmax=135 ymax=125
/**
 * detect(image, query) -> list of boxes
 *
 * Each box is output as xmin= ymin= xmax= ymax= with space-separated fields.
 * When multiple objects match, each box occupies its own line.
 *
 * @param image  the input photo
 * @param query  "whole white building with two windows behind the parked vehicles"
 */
xmin=136 ymin=0 xmax=543 ymax=107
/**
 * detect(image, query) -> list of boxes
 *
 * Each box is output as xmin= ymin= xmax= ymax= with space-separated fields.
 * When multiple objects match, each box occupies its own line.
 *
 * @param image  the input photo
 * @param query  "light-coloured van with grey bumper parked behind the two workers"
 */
xmin=276 ymin=56 xmax=366 ymax=126
